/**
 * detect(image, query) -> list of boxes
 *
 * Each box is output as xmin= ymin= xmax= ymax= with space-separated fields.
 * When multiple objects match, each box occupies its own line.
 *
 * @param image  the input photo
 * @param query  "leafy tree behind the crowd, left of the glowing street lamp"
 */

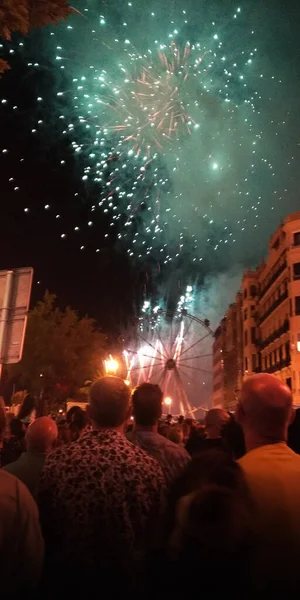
xmin=10 ymin=292 xmax=106 ymax=400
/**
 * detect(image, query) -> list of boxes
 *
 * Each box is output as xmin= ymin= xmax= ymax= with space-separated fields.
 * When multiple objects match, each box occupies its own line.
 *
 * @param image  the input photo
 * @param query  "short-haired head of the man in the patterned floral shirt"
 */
xmin=90 ymin=376 xmax=130 ymax=429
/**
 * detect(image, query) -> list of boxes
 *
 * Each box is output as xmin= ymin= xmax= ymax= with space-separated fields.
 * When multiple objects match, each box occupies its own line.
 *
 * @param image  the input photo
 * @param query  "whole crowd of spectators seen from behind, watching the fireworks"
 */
xmin=0 ymin=374 xmax=300 ymax=600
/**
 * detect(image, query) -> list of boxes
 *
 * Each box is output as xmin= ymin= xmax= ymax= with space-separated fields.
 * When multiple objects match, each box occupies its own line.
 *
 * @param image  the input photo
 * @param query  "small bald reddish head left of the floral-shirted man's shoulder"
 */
xmin=25 ymin=417 xmax=58 ymax=454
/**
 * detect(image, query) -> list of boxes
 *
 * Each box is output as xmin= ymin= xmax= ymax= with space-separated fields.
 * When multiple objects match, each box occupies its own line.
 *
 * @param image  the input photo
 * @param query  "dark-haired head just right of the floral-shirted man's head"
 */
xmin=132 ymin=383 xmax=163 ymax=427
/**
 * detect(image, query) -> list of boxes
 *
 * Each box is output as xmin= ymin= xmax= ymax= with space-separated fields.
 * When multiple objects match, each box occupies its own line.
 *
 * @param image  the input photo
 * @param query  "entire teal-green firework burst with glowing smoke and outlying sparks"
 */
xmin=1 ymin=0 xmax=294 ymax=328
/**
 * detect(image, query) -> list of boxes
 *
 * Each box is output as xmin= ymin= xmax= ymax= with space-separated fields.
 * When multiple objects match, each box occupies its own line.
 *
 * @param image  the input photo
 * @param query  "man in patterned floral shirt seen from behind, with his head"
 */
xmin=40 ymin=377 xmax=165 ymax=596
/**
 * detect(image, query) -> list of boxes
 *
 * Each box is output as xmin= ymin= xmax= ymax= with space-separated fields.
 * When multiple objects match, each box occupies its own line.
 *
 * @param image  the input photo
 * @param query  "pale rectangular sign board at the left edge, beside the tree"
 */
xmin=0 ymin=267 xmax=33 ymax=365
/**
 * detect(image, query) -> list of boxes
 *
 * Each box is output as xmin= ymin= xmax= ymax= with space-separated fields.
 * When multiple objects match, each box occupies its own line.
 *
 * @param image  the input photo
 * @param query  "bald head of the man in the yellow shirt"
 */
xmin=237 ymin=373 xmax=293 ymax=443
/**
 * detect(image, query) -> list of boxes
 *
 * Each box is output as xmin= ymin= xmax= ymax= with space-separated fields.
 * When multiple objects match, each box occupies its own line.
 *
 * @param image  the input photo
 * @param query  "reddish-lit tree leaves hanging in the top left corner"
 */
xmin=0 ymin=0 xmax=74 ymax=73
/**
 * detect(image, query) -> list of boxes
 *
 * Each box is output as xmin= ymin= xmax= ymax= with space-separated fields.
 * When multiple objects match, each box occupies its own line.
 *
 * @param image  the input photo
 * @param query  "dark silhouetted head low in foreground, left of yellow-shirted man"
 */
xmin=168 ymin=450 xmax=252 ymax=591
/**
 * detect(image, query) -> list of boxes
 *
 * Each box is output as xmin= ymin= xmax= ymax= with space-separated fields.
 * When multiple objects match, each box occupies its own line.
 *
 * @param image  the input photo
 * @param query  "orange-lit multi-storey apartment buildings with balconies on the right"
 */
xmin=213 ymin=212 xmax=300 ymax=407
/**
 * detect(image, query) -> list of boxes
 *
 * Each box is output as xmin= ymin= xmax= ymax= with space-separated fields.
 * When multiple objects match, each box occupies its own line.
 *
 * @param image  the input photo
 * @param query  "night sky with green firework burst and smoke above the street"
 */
xmin=0 ymin=0 xmax=300 ymax=332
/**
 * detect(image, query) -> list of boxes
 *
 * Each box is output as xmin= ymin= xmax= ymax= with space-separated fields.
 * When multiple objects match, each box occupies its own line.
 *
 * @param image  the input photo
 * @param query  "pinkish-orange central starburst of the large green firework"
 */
xmin=103 ymin=42 xmax=211 ymax=158
